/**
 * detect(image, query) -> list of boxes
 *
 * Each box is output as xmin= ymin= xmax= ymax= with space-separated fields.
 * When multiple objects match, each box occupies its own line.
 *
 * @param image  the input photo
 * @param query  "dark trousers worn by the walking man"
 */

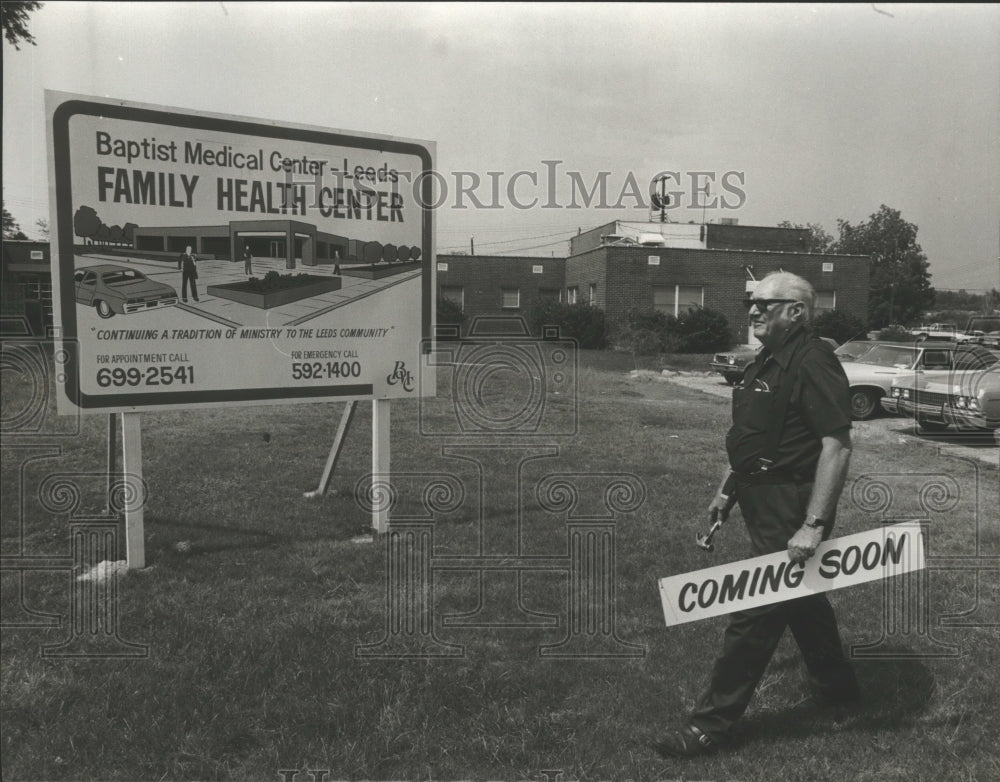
xmin=691 ymin=484 xmax=858 ymax=736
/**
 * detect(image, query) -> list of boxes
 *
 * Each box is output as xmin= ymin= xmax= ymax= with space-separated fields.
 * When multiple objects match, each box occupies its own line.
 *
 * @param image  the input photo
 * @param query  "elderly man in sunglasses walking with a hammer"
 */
xmin=655 ymin=272 xmax=859 ymax=757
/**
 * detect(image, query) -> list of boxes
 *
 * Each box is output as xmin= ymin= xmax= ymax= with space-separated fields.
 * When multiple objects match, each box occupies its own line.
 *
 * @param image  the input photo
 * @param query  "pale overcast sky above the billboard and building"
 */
xmin=3 ymin=2 xmax=1000 ymax=289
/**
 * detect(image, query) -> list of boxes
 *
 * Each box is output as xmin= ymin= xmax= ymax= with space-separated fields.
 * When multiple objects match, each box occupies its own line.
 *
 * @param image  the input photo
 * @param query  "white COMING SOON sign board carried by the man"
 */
xmin=660 ymin=522 xmax=924 ymax=626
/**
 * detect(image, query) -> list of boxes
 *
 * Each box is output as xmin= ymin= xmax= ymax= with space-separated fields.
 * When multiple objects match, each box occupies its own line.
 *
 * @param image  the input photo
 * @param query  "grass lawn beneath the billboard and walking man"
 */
xmin=0 ymin=352 xmax=1000 ymax=782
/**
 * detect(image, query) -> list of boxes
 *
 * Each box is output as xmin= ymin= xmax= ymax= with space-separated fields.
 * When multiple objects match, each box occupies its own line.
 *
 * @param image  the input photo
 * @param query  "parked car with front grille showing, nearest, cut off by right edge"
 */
xmin=882 ymin=363 xmax=1000 ymax=432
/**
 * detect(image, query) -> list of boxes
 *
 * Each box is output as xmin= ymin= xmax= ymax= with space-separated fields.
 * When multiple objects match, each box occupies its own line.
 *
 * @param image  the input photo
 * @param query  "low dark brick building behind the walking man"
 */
xmin=437 ymin=221 xmax=869 ymax=342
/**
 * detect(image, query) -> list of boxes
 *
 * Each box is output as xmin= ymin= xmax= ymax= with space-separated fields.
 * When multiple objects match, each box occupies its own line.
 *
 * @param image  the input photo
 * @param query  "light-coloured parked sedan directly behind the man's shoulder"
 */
xmin=843 ymin=342 xmax=1000 ymax=421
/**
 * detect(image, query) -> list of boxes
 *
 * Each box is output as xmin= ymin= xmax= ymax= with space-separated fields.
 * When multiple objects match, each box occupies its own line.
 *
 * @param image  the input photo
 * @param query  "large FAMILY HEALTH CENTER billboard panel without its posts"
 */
xmin=46 ymin=92 xmax=434 ymax=412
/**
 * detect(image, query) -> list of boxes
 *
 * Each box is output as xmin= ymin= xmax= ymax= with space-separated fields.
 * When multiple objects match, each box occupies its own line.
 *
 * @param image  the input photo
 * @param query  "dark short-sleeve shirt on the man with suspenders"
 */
xmin=726 ymin=329 xmax=851 ymax=478
